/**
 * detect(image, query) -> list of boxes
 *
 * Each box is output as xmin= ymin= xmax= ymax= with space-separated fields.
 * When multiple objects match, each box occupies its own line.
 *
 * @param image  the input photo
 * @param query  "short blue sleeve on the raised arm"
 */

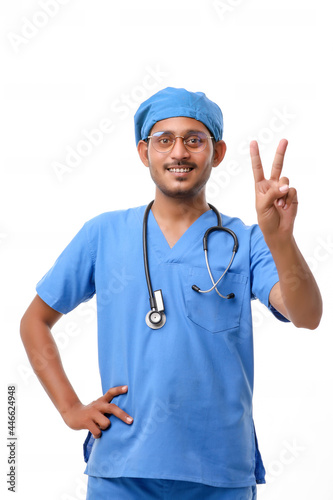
xmin=251 ymin=225 xmax=289 ymax=322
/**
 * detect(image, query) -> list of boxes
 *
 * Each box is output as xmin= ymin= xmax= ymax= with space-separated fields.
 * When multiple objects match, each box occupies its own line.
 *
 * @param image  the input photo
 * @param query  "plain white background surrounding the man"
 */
xmin=0 ymin=0 xmax=333 ymax=500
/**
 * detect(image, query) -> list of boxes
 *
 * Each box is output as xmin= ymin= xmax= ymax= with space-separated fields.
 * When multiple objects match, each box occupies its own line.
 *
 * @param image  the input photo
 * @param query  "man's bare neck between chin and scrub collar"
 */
xmin=152 ymin=189 xmax=210 ymax=223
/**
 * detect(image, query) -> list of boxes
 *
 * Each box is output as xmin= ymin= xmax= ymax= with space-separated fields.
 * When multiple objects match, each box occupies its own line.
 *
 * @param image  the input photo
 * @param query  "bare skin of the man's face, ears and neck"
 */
xmin=138 ymin=117 xmax=227 ymax=247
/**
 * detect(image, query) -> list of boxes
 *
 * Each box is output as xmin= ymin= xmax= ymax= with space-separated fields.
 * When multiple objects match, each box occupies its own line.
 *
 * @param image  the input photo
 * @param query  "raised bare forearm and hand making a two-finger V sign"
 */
xmin=250 ymin=139 xmax=322 ymax=330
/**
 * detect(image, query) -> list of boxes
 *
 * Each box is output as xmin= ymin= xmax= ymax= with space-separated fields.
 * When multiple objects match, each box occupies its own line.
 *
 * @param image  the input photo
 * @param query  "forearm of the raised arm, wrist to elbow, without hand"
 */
xmin=266 ymin=237 xmax=322 ymax=329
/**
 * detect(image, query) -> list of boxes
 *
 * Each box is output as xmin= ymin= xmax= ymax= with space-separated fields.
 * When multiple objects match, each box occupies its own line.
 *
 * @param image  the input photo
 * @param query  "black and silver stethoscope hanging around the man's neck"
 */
xmin=142 ymin=200 xmax=238 ymax=330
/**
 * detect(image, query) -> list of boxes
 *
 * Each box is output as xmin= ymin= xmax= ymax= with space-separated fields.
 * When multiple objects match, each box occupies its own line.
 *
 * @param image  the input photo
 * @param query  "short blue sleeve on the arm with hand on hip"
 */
xmin=36 ymin=223 xmax=95 ymax=314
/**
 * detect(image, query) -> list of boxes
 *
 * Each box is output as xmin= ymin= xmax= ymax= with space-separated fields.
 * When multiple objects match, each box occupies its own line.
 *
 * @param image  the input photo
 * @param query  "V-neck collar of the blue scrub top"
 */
xmin=147 ymin=206 xmax=217 ymax=262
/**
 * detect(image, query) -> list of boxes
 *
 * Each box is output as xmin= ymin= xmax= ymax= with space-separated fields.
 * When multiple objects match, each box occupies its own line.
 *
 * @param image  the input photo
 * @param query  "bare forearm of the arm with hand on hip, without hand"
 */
xmin=21 ymin=317 xmax=80 ymax=415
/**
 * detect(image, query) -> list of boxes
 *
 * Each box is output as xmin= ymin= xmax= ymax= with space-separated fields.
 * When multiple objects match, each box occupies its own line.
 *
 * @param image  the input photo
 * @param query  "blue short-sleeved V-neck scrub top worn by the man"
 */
xmin=36 ymin=206 xmax=284 ymax=488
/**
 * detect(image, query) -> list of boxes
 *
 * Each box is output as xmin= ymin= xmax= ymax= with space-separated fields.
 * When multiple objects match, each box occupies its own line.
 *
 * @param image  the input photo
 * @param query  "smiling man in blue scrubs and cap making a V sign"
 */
xmin=21 ymin=87 xmax=322 ymax=500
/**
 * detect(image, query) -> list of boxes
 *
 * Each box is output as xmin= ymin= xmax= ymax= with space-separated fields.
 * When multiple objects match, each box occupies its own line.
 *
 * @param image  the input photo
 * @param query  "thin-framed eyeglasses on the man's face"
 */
xmin=147 ymin=132 xmax=214 ymax=153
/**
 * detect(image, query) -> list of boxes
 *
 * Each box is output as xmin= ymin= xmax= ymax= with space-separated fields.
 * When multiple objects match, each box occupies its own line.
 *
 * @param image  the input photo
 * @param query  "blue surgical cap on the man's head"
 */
xmin=134 ymin=87 xmax=223 ymax=145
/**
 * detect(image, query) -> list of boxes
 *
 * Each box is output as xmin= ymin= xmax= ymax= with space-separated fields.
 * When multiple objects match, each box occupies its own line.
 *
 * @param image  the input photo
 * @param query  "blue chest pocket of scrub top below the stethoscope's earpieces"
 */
xmin=185 ymin=267 xmax=248 ymax=333
